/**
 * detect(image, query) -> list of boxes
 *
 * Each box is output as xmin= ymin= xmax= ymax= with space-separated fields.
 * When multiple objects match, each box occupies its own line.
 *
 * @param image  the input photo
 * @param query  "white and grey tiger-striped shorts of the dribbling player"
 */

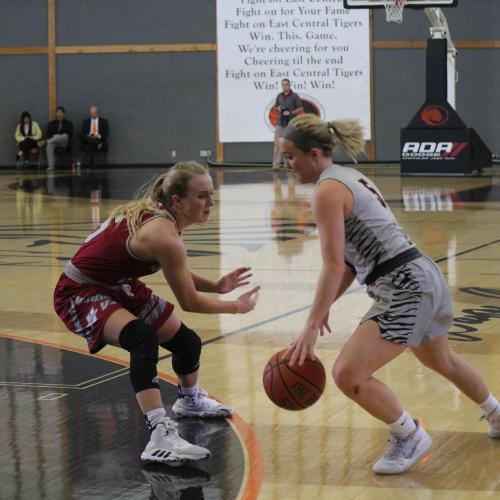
xmin=361 ymin=256 xmax=453 ymax=347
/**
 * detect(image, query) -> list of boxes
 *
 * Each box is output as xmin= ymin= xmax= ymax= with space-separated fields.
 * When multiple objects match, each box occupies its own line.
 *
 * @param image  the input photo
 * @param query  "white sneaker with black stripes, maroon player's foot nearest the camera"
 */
xmin=141 ymin=417 xmax=210 ymax=463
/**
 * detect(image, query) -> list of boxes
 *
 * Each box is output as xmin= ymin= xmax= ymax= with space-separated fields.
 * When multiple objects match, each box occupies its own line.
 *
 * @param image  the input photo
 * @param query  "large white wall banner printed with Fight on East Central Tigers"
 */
xmin=217 ymin=0 xmax=371 ymax=142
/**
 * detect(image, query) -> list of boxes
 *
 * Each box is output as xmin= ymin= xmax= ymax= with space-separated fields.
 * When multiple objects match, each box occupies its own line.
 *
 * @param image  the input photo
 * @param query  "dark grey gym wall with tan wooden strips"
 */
xmin=0 ymin=0 xmax=500 ymax=166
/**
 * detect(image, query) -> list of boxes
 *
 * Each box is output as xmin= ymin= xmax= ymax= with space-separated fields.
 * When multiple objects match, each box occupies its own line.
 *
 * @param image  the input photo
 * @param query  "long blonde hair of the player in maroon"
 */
xmin=108 ymin=161 xmax=208 ymax=237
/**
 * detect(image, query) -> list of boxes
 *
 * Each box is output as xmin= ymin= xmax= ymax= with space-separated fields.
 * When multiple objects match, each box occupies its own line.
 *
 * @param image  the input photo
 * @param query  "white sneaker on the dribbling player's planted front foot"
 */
xmin=373 ymin=420 xmax=432 ymax=474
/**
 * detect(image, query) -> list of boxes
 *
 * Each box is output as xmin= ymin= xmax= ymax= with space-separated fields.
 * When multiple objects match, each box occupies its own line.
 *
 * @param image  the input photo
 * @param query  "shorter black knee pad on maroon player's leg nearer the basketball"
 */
xmin=160 ymin=323 xmax=201 ymax=375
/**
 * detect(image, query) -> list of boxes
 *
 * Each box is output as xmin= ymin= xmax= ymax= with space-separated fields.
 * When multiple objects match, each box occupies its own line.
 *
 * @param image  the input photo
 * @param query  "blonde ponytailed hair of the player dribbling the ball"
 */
xmin=283 ymin=114 xmax=365 ymax=161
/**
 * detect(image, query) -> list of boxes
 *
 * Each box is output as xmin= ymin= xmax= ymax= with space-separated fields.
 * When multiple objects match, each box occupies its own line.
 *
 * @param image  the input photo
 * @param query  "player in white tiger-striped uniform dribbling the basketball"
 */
xmin=280 ymin=115 xmax=500 ymax=474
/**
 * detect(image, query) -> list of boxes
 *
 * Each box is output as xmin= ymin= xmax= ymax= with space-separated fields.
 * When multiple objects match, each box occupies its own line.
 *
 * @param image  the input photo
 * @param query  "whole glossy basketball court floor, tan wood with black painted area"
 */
xmin=0 ymin=166 xmax=500 ymax=500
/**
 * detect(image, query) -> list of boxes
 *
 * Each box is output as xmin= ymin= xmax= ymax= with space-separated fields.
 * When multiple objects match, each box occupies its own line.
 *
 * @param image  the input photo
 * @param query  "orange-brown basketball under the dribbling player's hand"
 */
xmin=263 ymin=349 xmax=326 ymax=411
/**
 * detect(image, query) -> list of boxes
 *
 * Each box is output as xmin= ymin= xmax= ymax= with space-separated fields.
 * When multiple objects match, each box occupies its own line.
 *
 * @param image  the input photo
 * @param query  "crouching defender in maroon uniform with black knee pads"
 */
xmin=54 ymin=162 xmax=259 ymax=462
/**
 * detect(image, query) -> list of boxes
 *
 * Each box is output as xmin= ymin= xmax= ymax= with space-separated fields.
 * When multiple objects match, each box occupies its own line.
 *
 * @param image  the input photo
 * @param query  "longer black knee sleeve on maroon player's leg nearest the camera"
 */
xmin=119 ymin=319 xmax=160 ymax=393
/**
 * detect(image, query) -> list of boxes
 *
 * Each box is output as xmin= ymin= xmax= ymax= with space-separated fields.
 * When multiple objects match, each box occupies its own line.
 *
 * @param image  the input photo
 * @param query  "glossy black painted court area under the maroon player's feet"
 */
xmin=0 ymin=338 xmax=244 ymax=500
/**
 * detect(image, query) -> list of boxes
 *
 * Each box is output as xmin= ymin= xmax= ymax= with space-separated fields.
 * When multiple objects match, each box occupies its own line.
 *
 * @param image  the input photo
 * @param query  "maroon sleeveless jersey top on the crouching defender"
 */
xmin=71 ymin=212 xmax=173 ymax=284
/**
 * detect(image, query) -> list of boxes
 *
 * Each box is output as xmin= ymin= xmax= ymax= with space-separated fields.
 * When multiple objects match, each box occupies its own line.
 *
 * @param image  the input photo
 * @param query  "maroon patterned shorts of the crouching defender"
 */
xmin=54 ymin=273 xmax=174 ymax=354
